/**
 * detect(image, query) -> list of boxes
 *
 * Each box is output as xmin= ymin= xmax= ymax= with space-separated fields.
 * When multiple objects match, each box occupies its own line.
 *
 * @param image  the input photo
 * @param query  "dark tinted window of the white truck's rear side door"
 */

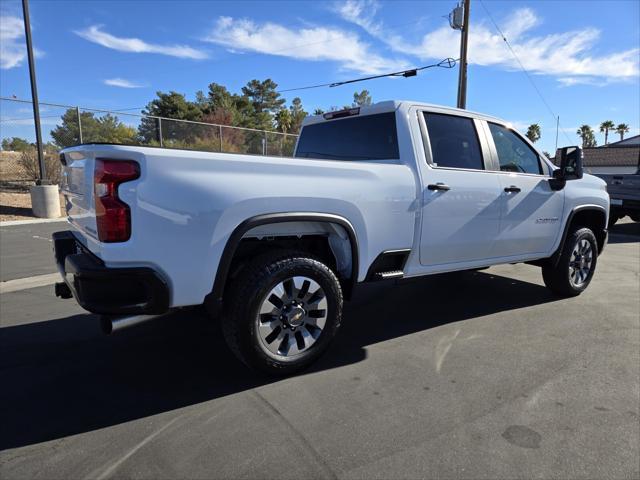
xmin=424 ymin=112 xmax=484 ymax=170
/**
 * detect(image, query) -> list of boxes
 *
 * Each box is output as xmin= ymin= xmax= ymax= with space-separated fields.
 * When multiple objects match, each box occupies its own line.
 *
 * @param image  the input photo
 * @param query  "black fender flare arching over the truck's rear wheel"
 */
xmin=205 ymin=212 xmax=359 ymax=305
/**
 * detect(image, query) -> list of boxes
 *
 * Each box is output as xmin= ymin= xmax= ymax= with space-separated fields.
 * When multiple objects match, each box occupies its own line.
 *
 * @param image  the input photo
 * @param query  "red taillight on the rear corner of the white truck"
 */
xmin=93 ymin=160 xmax=140 ymax=242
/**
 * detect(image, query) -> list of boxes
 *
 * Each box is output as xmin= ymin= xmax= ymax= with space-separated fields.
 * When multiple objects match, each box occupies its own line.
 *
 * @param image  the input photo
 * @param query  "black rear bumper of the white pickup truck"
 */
xmin=53 ymin=230 xmax=169 ymax=315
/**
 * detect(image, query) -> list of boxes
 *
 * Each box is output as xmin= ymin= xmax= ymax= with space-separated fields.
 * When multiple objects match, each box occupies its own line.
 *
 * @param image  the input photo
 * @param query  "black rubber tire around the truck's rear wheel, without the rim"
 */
xmin=222 ymin=251 xmax=342 ymax=376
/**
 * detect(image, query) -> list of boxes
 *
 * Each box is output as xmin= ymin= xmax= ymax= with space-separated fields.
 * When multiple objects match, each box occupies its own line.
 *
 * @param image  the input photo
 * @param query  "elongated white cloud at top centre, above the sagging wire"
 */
xmin=203 ymin=17 xmax=406 ymax=74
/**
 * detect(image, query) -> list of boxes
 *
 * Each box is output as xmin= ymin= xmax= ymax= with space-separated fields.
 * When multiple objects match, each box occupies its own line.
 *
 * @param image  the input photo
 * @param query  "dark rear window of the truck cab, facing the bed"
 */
xmin=295 ymin=112 xmax=400 ymax=161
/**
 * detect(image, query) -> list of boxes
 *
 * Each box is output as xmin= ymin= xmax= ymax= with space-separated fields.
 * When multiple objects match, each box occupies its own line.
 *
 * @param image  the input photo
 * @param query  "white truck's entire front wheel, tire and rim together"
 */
xmin=542 ymin=228 xmax=598 ymax=297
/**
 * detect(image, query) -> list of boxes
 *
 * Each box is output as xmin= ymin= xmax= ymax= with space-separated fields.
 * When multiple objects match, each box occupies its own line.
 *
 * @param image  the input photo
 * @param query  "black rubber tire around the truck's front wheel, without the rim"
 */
xmin=542 ymin=227 xmax=598 ymax=297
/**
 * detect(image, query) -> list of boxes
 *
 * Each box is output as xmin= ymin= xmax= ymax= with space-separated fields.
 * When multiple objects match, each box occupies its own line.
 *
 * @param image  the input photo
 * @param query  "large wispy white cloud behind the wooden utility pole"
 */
xmin=334 ymin=0 xmax=640 ymax=86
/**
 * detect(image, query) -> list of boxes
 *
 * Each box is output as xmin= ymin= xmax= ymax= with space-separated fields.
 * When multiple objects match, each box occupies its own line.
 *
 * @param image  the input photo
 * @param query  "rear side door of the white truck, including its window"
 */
xmin=419 ymin=112 xmax=502 ymax=270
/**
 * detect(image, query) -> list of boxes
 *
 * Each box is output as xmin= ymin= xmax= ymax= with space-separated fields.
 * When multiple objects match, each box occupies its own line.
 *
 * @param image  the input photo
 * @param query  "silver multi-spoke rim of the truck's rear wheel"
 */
xmin=256 ymin=276 xmax=327 ymax=358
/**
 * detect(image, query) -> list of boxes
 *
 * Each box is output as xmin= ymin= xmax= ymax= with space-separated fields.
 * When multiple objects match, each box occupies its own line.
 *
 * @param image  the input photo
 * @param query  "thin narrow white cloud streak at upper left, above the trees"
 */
xmin=74 ymin=25 xmax=207 ymax=60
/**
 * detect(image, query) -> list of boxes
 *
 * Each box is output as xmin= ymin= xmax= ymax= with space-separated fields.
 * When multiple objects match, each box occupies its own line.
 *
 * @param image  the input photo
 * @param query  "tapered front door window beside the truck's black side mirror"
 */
xmin=489 ymin=123 xmax=542 ymax=175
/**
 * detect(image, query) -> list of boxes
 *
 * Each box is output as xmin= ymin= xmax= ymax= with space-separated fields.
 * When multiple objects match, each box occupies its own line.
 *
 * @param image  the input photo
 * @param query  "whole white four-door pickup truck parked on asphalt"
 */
xmin=54 ymin=101 xmax=609 ymax=374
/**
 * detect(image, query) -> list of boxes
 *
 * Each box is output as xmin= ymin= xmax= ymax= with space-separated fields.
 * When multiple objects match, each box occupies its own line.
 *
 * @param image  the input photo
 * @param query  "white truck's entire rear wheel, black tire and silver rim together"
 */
xmin=222 ymin=251 xmax=342 ymax=375
